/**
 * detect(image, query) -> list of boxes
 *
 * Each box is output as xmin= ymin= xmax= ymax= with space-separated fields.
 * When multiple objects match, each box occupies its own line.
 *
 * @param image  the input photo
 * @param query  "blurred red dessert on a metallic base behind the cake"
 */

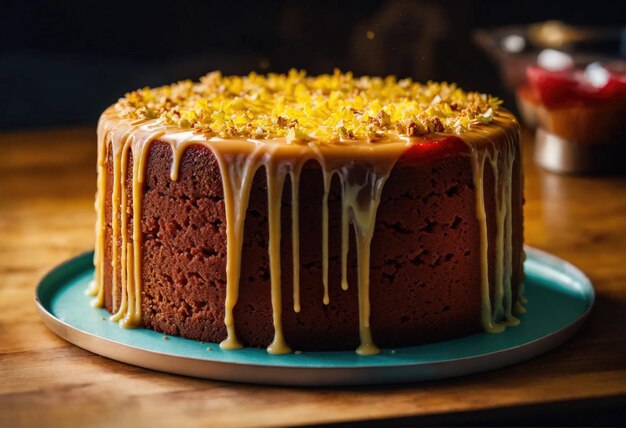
xmin=517 ymin=61 xmax=626 ymax=172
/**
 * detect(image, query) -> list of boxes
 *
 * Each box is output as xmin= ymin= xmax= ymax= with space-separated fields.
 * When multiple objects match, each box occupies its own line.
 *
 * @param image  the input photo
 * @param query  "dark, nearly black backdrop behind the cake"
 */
xmin=0 ymin=0 xmax=626 ymax=128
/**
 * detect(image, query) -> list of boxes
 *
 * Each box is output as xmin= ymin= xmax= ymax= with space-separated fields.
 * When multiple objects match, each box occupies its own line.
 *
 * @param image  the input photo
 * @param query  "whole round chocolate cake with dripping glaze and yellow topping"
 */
xmin=90 ymin=70 xmax=525 ymax=355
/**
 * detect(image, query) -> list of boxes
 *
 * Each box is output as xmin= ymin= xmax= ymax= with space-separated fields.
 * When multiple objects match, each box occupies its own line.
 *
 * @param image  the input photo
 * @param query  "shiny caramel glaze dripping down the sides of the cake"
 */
xmin=88 ymin=107 xmax=525 ymax=355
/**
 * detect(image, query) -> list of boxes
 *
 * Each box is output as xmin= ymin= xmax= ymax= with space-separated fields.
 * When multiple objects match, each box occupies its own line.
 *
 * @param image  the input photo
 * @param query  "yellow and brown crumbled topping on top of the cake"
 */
xmin=115 ymin=70 xmax=501 ymax=143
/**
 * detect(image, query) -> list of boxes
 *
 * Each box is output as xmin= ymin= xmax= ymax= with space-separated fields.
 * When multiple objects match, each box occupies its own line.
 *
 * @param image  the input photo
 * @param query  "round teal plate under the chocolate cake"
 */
xmin=36 ymin=248 xmax=594 ymax=386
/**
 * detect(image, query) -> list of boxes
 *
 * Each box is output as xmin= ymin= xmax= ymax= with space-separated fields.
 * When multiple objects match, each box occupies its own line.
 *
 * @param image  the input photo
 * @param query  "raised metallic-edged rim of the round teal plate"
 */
xmin=34 ymin=246 xmax=596 ymax=386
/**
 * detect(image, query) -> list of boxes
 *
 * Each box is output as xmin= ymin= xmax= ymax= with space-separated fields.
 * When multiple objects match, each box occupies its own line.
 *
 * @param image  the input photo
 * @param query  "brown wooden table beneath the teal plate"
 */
xmin=0 ymin=127 xmax=626 ymax=427
